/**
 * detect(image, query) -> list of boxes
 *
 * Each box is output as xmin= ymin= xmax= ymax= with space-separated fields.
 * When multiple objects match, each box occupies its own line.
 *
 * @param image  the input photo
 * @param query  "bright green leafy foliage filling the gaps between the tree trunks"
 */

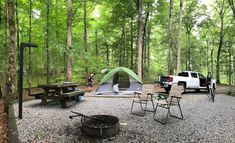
xmin=0 ymin=0 xmax=235 ymax=86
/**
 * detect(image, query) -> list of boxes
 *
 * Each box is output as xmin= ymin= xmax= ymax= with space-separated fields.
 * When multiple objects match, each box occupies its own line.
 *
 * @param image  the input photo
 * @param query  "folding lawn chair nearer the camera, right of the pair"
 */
xmin=153 ymin=85 xmax=183 ymax=125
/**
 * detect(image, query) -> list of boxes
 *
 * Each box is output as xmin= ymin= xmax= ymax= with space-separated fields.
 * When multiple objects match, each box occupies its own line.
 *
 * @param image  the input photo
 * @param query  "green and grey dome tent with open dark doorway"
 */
xmin=96 ymin=67 xmax=142 ymax=94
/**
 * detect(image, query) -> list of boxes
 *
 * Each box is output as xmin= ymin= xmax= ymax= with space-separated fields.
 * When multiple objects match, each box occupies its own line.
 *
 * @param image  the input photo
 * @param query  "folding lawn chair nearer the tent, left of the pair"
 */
xmin=131 ymin=85 xmax=154 ymax=116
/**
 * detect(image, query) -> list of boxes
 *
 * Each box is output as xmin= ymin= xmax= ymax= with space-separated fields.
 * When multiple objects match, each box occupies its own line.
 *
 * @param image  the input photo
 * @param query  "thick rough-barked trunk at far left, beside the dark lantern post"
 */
xmin=6 ymin=0 xmax=16 ymax=96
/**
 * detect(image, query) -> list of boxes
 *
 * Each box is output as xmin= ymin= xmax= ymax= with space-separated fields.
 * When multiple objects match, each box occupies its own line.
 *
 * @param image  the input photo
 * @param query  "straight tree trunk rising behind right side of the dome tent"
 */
xmin=137 ymin=0 xmax=142 ymax=81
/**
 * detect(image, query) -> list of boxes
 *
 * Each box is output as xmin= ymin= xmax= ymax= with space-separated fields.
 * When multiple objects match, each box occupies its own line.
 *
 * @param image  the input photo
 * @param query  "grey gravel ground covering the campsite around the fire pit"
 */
xmin=14 ymin=93 xmax=235 ymax=143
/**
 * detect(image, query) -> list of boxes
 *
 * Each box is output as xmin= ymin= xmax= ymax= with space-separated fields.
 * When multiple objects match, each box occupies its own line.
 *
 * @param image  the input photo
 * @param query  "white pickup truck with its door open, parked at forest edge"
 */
xmin=160 ymin=71 xmax=216 ymax=92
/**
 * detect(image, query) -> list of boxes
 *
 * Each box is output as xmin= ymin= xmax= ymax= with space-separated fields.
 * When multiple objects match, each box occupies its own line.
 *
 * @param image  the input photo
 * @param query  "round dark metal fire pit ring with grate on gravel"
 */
xmin=69 ymin=111 xmax=119 ymax=138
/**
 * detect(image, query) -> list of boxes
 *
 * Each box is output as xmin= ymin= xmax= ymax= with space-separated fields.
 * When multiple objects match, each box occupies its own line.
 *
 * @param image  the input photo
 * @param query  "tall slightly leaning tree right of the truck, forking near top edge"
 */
xmin=215 ymin=0 xmax=227 ymax=83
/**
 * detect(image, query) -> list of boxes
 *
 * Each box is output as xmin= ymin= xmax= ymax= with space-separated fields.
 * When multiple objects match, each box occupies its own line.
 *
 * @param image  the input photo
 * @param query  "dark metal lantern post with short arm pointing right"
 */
xmin=18 ymin=43 xmax=38 ymax=119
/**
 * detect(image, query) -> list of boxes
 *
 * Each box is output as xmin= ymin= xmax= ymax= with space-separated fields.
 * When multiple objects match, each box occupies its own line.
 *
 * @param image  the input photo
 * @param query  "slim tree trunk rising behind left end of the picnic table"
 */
xmin=45 ymin=0 xmax=50 ymax=84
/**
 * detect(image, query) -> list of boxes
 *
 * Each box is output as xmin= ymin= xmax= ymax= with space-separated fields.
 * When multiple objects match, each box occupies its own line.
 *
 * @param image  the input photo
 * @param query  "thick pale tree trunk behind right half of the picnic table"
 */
xmin=66 ymin=0 xmax=72 ymax=81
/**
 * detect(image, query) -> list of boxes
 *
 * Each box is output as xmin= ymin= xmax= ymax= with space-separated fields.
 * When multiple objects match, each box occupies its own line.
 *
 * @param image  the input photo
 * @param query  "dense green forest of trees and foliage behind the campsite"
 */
xmin=0 ymin=0 xmax=235 ymax=97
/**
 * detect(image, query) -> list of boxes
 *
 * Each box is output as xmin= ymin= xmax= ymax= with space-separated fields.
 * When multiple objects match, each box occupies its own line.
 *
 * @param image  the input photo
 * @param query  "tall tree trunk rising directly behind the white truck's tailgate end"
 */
xmin=168 ymin=0 xmax=174 ymax=75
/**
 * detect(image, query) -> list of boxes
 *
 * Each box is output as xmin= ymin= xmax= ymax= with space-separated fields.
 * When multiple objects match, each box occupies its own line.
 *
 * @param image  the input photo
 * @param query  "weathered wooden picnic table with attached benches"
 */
xmin=38 ymin=82 xmax=85 ymax=108
